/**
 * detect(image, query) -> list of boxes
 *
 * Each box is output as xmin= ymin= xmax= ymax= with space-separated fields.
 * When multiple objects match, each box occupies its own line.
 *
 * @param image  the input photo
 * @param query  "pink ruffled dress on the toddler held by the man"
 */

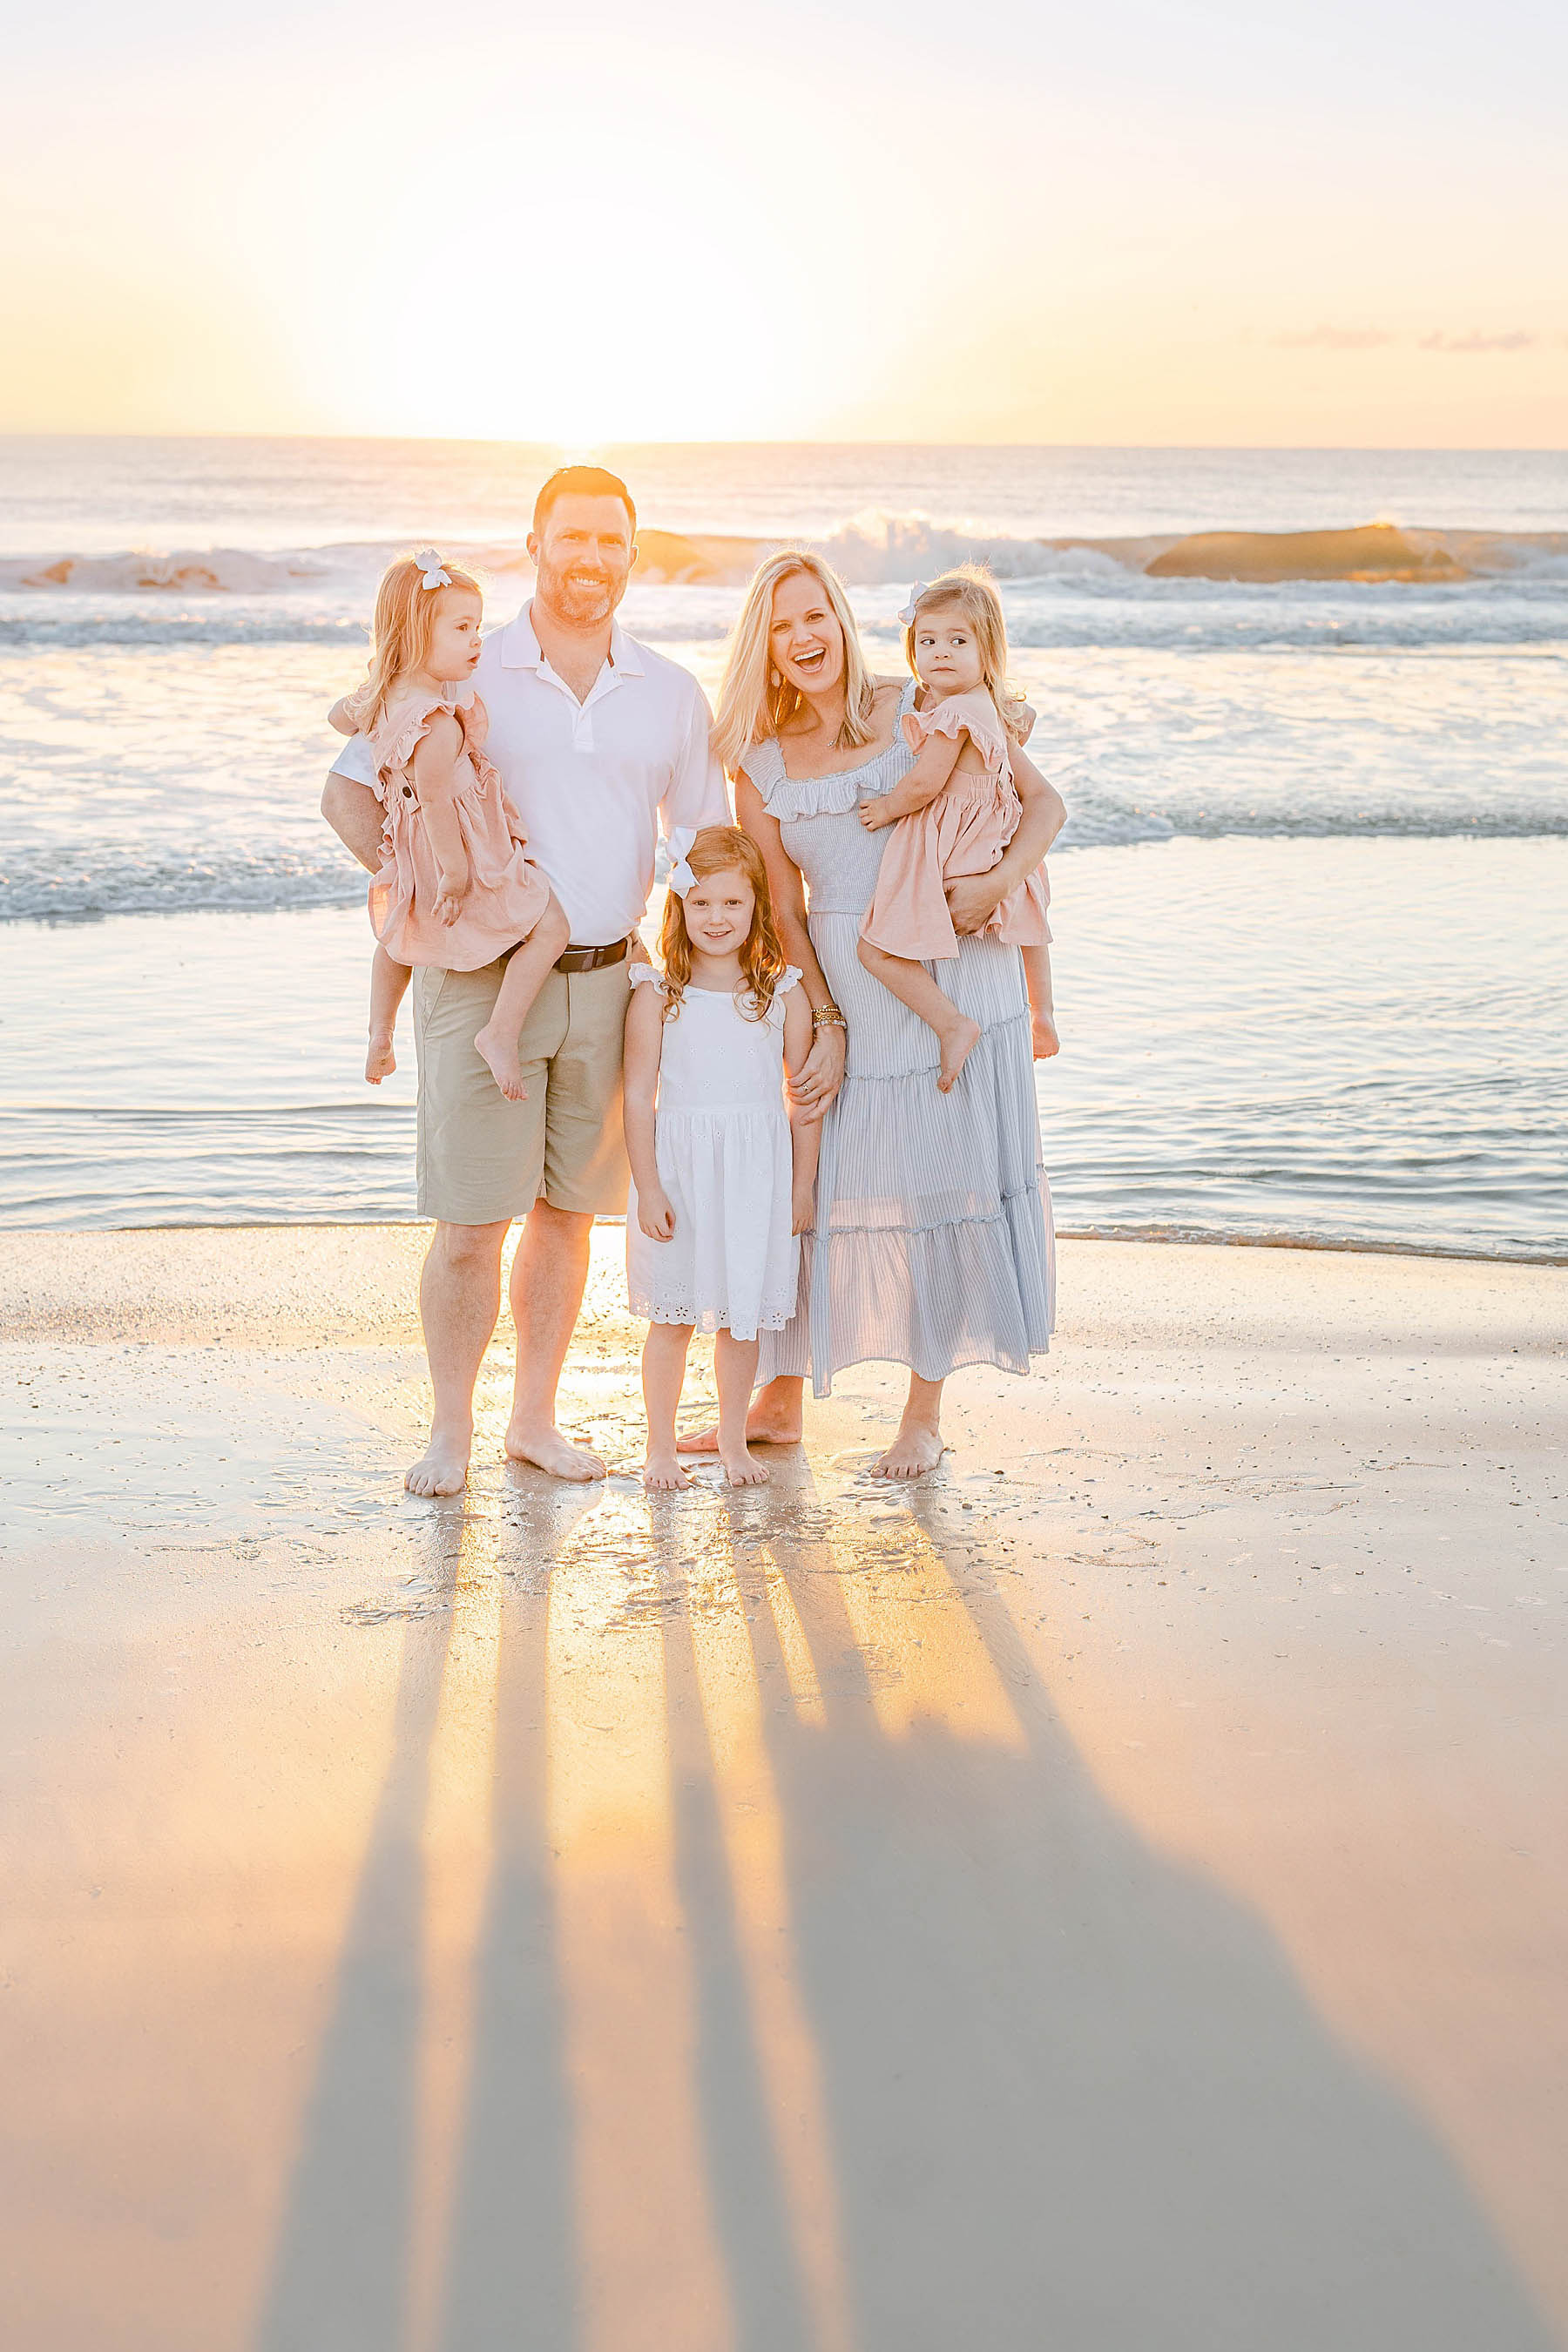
xmin=348 ymin=686 xmax=550 ymax=971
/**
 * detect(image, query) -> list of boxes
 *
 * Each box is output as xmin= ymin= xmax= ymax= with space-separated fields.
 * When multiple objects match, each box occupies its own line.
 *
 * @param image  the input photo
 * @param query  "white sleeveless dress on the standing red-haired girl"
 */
xmin=625 ymin=964 xmax=800 ymax=1341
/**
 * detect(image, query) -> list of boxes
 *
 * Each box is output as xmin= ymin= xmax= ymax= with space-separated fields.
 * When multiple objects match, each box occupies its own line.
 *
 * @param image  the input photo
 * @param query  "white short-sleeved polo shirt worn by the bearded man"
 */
xmin=334 ymin=605 xmax=731 ymax=948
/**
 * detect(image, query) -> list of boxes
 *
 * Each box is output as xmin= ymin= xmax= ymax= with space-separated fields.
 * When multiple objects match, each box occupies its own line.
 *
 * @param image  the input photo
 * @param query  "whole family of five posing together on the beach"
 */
xmin=322 ymin=466 xmax=1064 ymax=1496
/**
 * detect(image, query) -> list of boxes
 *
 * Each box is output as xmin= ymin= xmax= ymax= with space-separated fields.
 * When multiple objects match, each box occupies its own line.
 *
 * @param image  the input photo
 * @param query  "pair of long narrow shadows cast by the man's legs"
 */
xmin=253 ymin=1489 xmax=592 ymax=2352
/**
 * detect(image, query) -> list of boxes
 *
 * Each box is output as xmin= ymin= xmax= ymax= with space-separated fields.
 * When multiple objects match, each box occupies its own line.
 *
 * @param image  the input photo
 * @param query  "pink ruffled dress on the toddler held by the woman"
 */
xmin=861 ymin=686 xmax=1051 ymax=964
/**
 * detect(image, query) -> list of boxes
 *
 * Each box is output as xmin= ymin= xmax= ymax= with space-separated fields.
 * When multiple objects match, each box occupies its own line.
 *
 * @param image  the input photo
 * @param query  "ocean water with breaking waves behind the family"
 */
xmin=0 ymin=440 xmax=1568 ymax=1256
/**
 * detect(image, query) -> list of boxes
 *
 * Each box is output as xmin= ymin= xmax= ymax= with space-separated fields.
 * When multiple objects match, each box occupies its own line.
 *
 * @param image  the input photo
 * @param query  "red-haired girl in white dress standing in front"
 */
xmin=625 ymin=826 xmax=821 ymax=1486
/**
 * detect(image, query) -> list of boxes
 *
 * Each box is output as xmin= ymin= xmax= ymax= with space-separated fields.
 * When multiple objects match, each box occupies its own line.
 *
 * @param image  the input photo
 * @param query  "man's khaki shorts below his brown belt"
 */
xmin=414 ymin=957 xmax=630 ymax=1226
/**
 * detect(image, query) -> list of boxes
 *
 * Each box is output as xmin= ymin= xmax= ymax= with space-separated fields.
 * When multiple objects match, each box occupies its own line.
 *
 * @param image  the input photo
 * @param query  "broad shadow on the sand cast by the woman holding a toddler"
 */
xmin=719 ymin=1512 xmax=1551 ymax=2352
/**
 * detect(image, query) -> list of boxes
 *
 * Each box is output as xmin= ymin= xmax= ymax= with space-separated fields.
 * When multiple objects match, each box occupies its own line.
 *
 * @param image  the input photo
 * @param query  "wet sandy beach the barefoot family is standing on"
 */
xmin=0 ymin=1227 xmax=1568 ymax=2352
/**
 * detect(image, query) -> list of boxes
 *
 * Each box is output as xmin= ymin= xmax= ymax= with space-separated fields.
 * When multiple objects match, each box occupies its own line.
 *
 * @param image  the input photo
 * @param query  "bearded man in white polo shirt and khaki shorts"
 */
xmin=322 ymin=466 xmax=729 ymax=1494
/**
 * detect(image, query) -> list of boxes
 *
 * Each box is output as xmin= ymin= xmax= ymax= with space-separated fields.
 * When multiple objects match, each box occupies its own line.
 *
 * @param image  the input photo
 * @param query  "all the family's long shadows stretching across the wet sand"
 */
xmin=256 ymin=1477 xmax=1551 ymax=2352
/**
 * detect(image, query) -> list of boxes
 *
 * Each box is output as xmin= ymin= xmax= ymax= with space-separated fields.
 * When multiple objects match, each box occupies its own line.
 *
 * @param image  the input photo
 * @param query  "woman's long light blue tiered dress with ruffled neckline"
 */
xmin=745 ymin=685 xmax=1056 ymax=1397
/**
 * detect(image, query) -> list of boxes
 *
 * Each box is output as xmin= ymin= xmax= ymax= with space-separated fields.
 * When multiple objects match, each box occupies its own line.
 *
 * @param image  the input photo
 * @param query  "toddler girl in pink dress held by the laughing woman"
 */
xmin=861 ymin=567 xmax=1058 ymax=1094
